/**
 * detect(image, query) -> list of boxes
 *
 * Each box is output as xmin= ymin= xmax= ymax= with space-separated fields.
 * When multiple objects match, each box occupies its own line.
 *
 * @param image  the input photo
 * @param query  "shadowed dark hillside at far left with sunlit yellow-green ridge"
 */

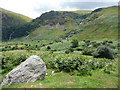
xmin=0 ymin=8 xmax=32 ymax=40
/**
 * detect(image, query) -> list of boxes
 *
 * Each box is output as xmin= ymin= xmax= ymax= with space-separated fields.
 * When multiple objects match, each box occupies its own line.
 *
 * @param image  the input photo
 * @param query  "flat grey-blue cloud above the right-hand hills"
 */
xmin=61 ymin=2 xmax=118 ymax=10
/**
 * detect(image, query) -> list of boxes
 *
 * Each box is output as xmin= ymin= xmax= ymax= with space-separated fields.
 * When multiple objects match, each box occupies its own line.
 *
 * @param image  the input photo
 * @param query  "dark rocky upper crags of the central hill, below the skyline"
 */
xmin=33 ymin=11 xmax=86 ymax=26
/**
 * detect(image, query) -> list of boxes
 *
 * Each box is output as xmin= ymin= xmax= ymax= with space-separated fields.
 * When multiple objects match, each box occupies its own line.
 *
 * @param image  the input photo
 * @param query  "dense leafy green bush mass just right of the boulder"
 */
xmin=46 ymin=54 xmax=112 ymax=76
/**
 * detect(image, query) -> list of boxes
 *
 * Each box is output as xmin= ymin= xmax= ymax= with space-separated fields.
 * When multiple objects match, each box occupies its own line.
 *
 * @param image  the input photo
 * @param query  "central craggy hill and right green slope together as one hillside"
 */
xmin=24 ymin=6 xmax=118 ymax=40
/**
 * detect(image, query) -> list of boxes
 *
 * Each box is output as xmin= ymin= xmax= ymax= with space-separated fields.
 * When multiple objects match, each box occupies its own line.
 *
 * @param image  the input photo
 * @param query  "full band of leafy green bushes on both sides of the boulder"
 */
xmin=0 ymin=53 xmax=115 ymax=76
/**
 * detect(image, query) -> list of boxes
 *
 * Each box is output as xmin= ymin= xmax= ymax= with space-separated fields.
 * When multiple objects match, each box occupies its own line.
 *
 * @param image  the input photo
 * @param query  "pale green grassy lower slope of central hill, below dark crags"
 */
xmin=22 ymin=22 xmax=79 ymax=41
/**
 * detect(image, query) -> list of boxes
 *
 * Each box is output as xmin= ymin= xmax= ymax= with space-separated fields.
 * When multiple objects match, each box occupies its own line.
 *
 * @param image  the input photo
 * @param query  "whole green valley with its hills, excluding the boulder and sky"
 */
xmin=0 ymin=6 xmax=120 ymax=88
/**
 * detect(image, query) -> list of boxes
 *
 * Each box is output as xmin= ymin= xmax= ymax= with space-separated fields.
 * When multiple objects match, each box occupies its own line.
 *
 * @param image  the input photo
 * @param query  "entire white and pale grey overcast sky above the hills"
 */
xmin=0 ymin=0 xmax=119 ymax=18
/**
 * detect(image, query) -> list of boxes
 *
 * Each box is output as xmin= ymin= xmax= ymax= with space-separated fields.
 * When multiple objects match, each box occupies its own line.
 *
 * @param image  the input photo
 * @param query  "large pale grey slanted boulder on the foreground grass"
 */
xmin=0 ymin=55 xmax=46 ymax=86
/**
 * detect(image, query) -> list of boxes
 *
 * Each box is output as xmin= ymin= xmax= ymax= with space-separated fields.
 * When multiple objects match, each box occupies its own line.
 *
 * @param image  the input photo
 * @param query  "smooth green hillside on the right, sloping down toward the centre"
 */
xmin=73 ymin=6 xmax=120 ymax=39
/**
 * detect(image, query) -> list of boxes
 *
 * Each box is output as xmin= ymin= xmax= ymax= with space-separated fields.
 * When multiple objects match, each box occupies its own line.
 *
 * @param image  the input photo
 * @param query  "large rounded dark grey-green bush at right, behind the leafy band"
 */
xmin=92 ymin=45 xmax=114 ymax=59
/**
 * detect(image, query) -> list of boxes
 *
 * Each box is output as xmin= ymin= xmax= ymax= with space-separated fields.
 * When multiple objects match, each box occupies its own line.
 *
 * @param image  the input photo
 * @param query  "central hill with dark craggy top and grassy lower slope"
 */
xmin=24 ymin=11 xmax=89 ymax=40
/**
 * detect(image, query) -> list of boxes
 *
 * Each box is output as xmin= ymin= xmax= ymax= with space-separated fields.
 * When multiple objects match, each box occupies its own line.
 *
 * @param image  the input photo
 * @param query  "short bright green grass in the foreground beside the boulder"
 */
xmin=3 ymin=69 xmax=118 ymax=88
